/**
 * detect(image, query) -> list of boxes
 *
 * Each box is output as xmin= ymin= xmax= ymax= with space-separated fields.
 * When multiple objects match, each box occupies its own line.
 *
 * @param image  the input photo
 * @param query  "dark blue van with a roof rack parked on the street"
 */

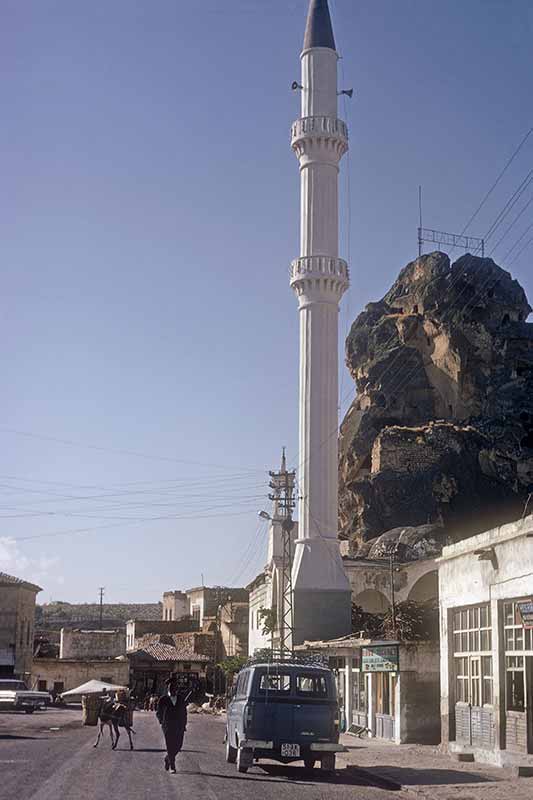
xmin=226 ymin=662 xmax=346 ymax=773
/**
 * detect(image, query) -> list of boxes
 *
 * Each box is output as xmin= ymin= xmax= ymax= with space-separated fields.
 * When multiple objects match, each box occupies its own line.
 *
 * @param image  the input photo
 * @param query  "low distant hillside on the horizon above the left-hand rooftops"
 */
xmin=35 ymin=601 xmax=163 ymax=629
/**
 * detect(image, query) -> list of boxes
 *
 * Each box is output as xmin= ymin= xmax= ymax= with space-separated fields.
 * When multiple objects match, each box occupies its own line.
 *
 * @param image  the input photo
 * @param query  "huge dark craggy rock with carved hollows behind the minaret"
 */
xmin=339 ymin=253 xmax=533 ymax=553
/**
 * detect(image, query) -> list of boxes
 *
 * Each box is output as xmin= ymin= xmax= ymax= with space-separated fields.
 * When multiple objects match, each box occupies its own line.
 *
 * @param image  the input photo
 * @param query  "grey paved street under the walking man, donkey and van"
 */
xmin=0 ymin=710 xmax=403 ymax=800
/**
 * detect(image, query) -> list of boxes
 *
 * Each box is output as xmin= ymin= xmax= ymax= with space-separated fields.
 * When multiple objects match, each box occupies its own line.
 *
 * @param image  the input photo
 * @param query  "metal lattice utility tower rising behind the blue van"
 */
xmin=268 ymin=448 xmax=296 ymax=660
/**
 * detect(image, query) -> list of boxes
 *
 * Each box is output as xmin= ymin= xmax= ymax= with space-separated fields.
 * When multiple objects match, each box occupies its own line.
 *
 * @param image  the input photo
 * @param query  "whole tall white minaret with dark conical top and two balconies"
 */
xmin=290 ymin=0 xmax=350 ymax=644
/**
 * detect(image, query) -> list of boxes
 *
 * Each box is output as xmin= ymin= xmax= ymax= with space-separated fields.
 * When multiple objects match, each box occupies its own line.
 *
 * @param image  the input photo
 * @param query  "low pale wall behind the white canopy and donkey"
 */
xmin=31 ymin=658 xmax=130 ymax=692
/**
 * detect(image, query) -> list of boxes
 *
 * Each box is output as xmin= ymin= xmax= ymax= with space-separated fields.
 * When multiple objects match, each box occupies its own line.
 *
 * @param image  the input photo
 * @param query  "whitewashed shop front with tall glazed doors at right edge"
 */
xmin=438 ymin=515 xmax=533 ymax=765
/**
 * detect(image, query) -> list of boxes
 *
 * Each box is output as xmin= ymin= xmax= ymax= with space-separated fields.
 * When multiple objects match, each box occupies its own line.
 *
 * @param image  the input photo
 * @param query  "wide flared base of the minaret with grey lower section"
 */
xmin=292 ymin=537 xmax=352 ymax=645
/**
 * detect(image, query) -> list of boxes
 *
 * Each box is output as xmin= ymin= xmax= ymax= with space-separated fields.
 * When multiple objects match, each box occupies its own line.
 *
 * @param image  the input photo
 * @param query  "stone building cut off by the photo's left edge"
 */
xmin=0 ymin=572 xmax=42 ymax=680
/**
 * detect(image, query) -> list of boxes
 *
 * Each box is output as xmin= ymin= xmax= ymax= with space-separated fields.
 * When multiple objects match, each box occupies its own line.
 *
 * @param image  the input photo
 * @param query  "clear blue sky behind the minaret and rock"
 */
xmin=0 ymin=0 xmax=533 ymax=602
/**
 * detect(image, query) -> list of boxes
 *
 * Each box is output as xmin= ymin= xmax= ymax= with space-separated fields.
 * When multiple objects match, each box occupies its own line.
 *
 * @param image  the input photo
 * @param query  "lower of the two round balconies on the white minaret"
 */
xmin=289 ymin=256 xmax=350 ymax=301
